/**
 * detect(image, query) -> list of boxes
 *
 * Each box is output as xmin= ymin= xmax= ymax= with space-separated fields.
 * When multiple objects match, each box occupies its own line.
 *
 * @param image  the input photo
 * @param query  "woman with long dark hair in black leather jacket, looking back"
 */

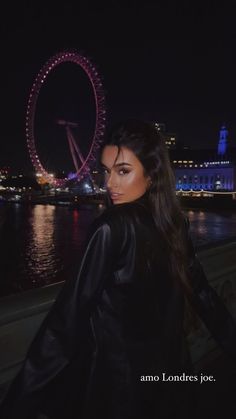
xmin=1 ymin=120 xmax=236 ymax=419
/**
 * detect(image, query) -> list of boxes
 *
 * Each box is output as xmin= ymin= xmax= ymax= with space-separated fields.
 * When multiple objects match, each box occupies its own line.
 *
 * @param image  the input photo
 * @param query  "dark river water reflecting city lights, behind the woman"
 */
xmin=0 ymin=204 xmax=236 ymax=296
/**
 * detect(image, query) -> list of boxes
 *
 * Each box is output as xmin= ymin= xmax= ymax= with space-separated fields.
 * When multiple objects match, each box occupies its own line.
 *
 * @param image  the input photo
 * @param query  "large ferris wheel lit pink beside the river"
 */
xmin=26 ymin=51 xmax=106 ymax=186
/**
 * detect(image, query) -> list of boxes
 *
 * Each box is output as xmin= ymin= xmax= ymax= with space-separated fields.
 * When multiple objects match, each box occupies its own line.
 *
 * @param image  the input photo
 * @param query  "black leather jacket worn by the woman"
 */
xmin=1 ymin=194 xmax=236 ymax=419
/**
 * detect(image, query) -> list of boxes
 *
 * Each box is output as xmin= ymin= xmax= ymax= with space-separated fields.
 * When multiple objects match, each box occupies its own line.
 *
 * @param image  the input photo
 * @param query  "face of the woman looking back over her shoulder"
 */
xmin=101 ymin=145 xmax=150 ymax=204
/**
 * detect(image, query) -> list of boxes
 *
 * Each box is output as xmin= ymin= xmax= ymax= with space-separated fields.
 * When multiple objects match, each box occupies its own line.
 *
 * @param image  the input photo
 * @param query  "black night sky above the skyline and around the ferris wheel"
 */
xmin=0 ymin=0 xmax=236 ymax=173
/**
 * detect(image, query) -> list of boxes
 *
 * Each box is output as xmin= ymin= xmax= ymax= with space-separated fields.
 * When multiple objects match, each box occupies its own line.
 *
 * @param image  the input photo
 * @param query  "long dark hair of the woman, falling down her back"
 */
xmin=100 ymin=119 xmax=197 ymax=332
